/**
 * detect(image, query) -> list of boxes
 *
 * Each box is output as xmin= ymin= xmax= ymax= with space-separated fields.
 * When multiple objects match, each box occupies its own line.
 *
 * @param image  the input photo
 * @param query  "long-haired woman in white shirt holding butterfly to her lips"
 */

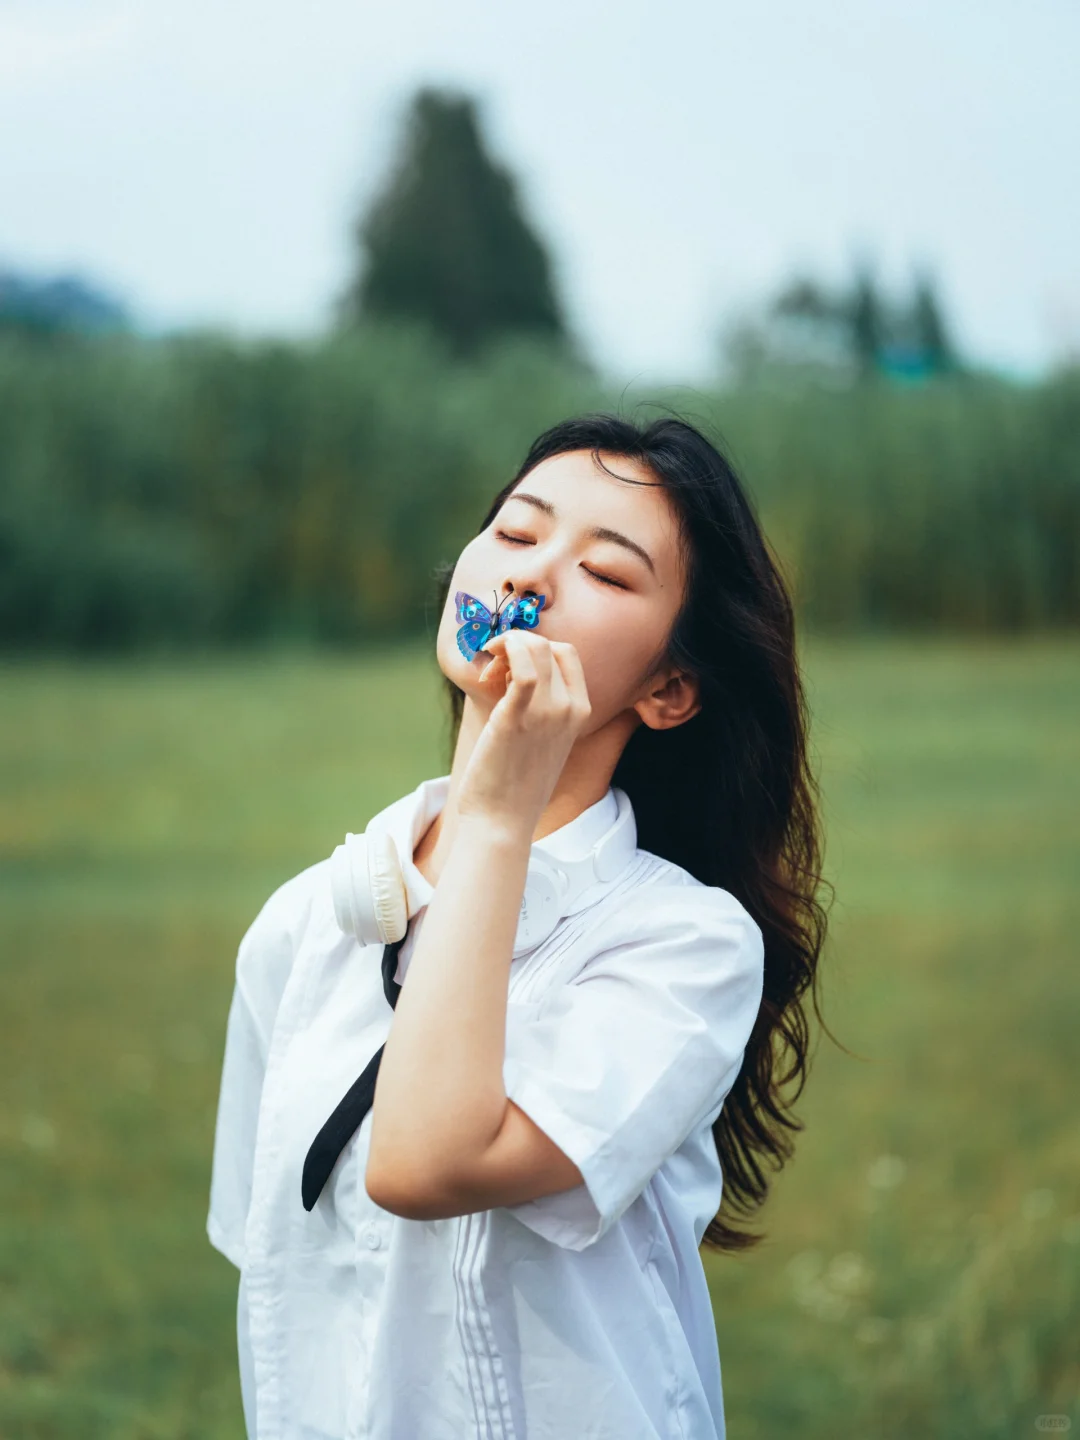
xmin=207 ymin=416 xmax=824 ymax=1440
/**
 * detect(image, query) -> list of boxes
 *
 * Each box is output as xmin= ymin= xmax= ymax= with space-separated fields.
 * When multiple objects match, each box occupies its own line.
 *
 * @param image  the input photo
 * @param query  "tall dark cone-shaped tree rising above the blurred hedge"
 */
xmin=341 ymin=89 xmax=564 ymax=356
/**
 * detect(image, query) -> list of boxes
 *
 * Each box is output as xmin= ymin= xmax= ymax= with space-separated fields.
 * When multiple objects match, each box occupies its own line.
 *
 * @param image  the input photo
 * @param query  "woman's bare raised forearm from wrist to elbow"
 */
xmin=367 ymin=816 xmax=531 ymax=1189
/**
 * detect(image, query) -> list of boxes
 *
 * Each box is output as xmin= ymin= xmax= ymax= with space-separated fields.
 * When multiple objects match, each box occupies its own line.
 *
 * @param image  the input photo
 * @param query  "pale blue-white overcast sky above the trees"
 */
xmin=0 ymin=0 xmax=1080 ymax=379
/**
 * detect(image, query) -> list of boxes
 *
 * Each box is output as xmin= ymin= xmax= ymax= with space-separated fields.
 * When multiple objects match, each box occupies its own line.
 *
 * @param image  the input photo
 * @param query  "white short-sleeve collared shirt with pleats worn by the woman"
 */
xmin=207 ymin=776 xmax=763 ymax=1440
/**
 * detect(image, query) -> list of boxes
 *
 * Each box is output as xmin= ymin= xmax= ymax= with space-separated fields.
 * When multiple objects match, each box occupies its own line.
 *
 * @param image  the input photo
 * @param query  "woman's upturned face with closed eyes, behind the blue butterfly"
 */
xmin=436 ymin=451 xmax=685 ymax=730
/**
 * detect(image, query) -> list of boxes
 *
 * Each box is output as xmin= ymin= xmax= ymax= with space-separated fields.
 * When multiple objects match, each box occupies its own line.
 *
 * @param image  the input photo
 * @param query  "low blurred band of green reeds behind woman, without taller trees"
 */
xmin=0 ymin=325 xmax=1080 ymax=648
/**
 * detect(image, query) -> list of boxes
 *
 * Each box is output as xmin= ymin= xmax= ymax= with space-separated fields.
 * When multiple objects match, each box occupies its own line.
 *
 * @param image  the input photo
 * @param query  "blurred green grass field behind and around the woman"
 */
xmin=0 ymin=639 xmax=1080 ymax=1440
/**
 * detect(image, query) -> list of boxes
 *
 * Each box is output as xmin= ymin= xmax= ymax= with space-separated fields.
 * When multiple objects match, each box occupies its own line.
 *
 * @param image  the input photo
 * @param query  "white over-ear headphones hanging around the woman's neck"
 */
xmin=330 ymin=786 xmax=636 ymax=958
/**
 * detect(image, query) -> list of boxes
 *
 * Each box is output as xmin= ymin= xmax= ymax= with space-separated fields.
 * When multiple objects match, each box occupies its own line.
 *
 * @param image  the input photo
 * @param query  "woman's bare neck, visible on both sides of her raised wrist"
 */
xmin=413 ymin=696 xmax=641 ymax=884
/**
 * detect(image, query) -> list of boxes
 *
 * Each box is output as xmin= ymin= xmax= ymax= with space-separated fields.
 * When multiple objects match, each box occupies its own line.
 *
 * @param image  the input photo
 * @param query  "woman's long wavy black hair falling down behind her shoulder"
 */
xmin=439 ymin=415 xmax=825 ymax=1251
